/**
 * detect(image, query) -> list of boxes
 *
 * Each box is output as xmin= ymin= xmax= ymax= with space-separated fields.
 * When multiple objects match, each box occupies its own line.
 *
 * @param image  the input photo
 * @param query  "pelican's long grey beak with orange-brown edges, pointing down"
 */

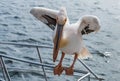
xmin=53 ymin=24 xmax=64 ymax=62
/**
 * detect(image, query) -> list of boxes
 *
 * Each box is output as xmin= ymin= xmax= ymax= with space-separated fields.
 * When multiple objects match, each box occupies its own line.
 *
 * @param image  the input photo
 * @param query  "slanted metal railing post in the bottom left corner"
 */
xmin=0 ymin=57 xmax=11 ymax=81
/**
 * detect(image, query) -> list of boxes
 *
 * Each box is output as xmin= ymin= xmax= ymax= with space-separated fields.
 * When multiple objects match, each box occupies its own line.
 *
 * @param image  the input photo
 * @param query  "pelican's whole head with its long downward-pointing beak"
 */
xmin=53 ymin=7 xmax=67 ymax=61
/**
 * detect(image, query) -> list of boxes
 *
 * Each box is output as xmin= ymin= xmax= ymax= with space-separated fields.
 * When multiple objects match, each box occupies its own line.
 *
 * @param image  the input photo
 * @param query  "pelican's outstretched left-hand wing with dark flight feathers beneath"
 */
xmin=30 ymin=7 xmax=58 ymax=30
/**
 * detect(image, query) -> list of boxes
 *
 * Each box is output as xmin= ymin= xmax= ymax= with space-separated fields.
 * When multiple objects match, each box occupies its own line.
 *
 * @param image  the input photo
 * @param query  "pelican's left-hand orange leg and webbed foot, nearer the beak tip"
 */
xmin=54 ymin=52 xmax=65 ymax=75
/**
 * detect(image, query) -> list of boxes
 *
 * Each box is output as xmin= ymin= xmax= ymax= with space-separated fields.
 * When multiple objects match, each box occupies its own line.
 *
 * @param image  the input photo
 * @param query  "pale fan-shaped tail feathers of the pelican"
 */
xmin=78 ymin=47 xmax=92 ymax=59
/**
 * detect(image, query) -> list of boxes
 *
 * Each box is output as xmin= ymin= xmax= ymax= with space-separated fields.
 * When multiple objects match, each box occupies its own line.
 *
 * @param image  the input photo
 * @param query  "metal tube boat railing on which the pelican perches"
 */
xmin=0 ymin=42 xmax=104 ymax=81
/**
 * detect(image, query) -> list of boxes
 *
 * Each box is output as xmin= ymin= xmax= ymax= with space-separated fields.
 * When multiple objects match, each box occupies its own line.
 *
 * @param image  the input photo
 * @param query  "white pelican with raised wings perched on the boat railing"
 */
xmin=30 ymin=7 xmax=100 ymax=75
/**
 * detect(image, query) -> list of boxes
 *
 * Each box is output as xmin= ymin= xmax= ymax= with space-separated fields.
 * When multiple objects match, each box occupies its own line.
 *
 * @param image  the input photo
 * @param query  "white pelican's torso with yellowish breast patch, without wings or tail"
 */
xmin=57 ymin=22 xmax=83 ymax=54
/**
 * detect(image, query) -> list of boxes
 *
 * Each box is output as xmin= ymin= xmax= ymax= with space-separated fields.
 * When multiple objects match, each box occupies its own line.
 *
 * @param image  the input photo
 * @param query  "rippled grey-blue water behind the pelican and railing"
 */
xmin=0 ymin=0 xmax=120 ymax=81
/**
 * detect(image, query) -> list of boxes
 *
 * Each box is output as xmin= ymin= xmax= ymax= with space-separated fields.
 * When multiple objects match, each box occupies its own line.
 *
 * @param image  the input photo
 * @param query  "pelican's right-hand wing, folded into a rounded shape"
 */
xmin=79 ymin=15 xmax=100 ymax=35
